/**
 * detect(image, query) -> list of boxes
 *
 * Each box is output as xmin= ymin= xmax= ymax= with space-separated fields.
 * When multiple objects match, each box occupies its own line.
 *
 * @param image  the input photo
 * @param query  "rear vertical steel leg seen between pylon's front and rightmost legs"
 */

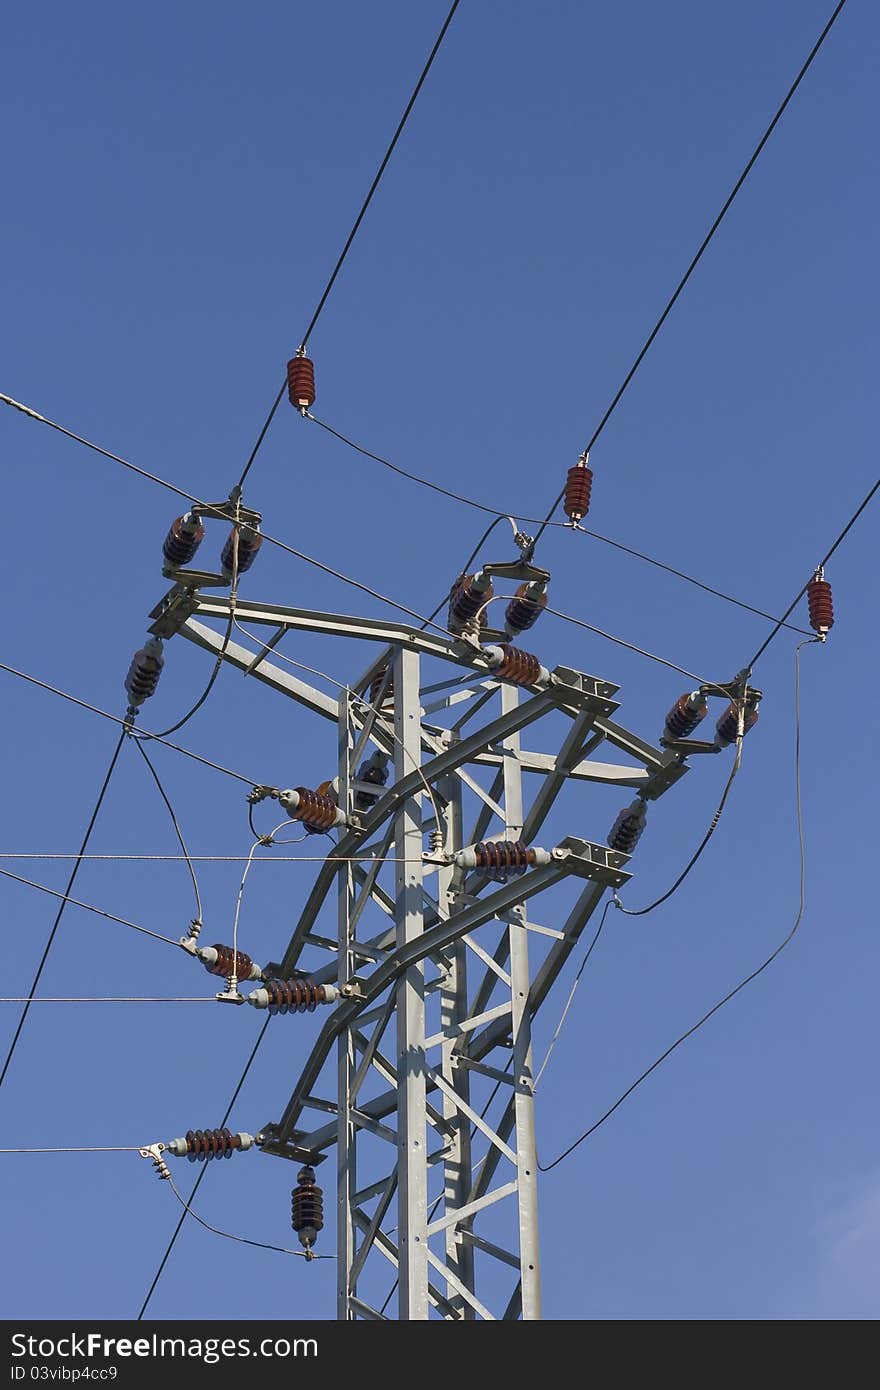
xmin=437 ymin=776 xmax=474 ymax=1319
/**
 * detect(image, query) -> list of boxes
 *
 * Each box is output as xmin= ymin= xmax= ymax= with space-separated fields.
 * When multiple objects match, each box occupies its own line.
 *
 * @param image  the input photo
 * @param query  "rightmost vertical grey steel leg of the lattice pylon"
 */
xmin=500 ymin=682 xmax=541 ymax=1322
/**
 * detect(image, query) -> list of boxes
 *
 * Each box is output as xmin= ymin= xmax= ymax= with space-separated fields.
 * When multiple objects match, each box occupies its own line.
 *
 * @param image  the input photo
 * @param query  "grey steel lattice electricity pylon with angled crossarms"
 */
xmin=152 ymin=566 xmax=686 ymax=1321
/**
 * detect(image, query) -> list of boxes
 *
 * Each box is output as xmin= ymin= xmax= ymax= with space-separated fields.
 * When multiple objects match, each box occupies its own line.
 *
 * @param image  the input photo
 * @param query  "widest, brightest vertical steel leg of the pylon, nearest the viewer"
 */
xmin=393 ymin=646 xmax=428 ymax=1321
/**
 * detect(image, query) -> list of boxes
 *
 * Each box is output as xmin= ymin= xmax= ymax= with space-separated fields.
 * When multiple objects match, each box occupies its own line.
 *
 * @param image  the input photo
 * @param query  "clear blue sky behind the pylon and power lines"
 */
xmin=0 ymin=0 xmax=880 ymax=1319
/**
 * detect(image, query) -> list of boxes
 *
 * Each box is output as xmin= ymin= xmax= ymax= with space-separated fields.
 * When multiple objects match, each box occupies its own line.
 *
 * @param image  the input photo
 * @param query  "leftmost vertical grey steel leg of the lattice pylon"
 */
xmin=336 ymin=689 xmax=357 ymax=1322
